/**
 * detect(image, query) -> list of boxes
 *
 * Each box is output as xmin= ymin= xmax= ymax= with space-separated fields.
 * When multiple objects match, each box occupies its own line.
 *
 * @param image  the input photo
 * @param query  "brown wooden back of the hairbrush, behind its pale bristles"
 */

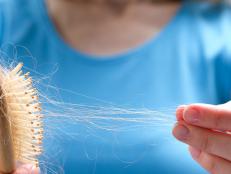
xmin=0 ymin=87 xmax=15 ymax=173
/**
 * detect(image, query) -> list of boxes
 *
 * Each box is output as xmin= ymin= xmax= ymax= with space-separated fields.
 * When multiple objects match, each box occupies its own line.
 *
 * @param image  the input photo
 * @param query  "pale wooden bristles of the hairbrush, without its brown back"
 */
xmin=1 ymin=63 xmax=43 ymax=167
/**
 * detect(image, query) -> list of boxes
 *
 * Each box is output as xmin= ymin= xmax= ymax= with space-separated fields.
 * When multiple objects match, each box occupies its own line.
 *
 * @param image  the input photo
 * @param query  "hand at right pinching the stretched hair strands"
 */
xmin=173 ymin=102 xmax=231 ymax=174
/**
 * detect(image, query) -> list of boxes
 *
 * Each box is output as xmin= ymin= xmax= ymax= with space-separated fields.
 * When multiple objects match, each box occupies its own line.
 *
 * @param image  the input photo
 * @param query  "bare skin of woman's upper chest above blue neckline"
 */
xmin=46 ymin=0 xmax=180 ymax=55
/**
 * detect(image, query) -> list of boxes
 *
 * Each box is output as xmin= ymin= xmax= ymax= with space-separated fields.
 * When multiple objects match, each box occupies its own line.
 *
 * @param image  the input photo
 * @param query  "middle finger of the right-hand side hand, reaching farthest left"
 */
xmin=173 ymin=121 xmax=231 ymax=161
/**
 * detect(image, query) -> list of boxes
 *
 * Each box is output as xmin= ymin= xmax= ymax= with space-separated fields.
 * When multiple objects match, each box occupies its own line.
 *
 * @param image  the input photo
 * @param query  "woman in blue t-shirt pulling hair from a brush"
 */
xmin=0 ymin=0 xmax=231 ymax=174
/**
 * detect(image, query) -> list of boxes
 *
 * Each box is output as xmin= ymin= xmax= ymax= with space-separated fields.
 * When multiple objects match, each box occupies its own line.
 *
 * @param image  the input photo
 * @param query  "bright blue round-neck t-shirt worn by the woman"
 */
xmin=0 ymin=0 xmax=231 ymax=174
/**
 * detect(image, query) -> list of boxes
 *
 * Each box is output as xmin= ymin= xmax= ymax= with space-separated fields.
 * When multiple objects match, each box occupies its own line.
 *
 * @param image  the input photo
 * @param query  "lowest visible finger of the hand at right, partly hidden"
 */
xmin=189 ymin=147 xmax=231 ymax=174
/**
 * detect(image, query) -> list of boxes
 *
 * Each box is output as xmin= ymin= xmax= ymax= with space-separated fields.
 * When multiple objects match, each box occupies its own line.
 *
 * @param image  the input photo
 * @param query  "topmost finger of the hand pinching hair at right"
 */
xmin=176 ymin=103 xmax=231 ymax=131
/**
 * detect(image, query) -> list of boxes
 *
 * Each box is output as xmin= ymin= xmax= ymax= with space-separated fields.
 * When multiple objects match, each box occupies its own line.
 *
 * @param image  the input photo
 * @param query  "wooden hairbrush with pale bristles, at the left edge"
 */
xmin=0 ymin=63 xmax=43 ymax=173
